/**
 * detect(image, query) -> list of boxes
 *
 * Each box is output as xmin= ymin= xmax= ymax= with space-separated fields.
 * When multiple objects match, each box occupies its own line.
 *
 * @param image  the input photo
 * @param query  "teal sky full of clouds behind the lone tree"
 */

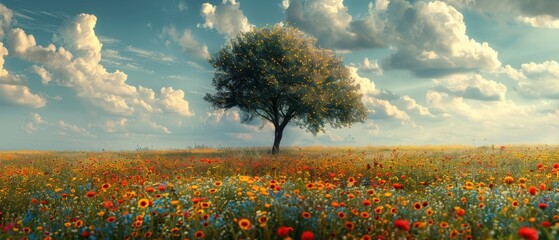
xmin=0 ymin=0 xmax=559 ymax=150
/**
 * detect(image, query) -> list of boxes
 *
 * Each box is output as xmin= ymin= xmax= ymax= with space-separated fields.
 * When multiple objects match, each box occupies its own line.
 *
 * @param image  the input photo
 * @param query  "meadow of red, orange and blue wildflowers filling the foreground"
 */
xmin=0 ymin=146 xmax=559 ymax=239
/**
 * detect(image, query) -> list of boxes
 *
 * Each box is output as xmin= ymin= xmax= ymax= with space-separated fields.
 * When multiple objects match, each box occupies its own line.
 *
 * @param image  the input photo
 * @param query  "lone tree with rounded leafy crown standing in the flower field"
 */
xmin=204 ymin=26 xmax=366 ymax=154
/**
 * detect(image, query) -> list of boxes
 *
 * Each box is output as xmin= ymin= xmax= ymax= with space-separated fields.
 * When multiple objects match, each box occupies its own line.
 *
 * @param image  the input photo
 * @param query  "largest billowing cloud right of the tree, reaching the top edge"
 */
xmin=384 ymin=1 xmax=501 ymax=77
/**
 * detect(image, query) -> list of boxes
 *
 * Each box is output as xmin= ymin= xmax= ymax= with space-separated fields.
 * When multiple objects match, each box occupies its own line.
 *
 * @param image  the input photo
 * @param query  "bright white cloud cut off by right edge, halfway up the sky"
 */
xmin=504 ymin=61 xmax=559 ymax=99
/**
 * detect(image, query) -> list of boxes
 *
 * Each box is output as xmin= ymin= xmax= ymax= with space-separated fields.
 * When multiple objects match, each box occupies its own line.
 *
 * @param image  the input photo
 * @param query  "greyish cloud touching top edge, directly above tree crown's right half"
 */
xmin=283 ymin=0 xmax=388 ymax=50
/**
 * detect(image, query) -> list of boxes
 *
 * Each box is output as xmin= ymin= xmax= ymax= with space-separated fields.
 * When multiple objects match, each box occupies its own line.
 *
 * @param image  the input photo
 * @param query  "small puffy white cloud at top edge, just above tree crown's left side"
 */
xmin=198 ymin=1 xmax=253 ymax=38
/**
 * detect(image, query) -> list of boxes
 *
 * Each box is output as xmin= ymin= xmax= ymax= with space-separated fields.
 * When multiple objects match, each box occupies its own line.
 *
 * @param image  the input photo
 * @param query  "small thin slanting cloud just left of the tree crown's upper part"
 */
xmin=165 ymin=26 xmax=210 ymax=59
